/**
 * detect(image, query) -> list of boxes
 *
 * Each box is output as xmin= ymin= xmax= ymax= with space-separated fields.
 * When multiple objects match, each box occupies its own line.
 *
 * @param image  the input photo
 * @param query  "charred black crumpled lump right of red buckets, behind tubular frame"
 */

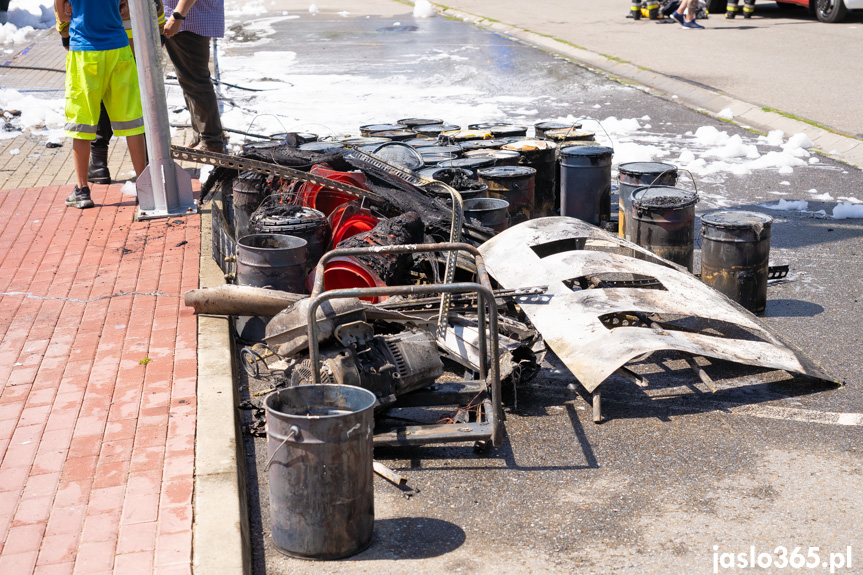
xmin=337 ymin=212 xmax=424 ymax=285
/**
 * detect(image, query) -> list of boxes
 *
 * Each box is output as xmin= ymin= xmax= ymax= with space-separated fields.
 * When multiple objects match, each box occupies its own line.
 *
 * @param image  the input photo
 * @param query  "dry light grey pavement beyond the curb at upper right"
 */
xmin=442 ymin=0 xmax=863 ymax=138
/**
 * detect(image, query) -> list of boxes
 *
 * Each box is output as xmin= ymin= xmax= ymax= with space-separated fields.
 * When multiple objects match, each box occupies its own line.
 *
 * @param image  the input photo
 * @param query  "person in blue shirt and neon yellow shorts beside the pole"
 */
xmin=54 ymin=0 xmax=146 ymax=209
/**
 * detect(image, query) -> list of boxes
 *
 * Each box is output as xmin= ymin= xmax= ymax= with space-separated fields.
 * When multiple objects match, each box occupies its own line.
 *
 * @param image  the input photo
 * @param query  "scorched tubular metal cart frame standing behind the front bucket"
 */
xmin=308 ymin=243 xmax=503 ymax=447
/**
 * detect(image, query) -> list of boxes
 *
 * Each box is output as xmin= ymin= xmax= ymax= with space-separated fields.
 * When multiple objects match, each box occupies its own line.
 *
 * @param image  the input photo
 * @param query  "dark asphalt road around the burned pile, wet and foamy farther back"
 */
xmin=236 ymin=0 xmax=863 ymax=575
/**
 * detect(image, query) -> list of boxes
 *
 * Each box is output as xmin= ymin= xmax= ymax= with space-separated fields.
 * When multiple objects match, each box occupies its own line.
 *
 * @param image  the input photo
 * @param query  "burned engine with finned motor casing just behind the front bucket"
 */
xmin=291 ymin=322 xmax=443 ymax=407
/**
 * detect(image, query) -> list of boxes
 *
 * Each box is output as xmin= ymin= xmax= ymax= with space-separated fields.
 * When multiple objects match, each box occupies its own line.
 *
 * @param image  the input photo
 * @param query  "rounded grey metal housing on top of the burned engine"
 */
xmin=264 ymin=298 xmax=366 ymax=357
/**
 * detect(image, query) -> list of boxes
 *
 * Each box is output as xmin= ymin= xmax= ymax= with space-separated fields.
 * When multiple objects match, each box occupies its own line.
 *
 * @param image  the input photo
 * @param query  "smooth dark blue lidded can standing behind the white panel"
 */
xmin=560 ymin=145 xmax=614 ymax=226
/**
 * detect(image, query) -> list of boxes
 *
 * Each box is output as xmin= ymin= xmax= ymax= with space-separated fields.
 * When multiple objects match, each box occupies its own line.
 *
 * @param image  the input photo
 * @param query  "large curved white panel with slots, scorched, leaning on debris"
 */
xmin=480 ymin=217 xmax=836 ymax=400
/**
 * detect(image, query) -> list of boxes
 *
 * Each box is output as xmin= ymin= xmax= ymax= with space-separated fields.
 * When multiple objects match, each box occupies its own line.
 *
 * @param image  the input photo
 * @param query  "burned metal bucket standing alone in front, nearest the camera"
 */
xmin=264 ymin=385 xmax=376 ymax=559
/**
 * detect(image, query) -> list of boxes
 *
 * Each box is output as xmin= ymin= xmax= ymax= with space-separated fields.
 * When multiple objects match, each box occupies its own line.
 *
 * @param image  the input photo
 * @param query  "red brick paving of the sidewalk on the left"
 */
xmin=0 ymin=185 xmax=201 ymax=575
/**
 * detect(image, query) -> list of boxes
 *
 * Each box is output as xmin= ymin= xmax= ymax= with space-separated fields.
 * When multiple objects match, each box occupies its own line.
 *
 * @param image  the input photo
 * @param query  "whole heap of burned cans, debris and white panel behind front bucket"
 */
xmin=182 ymin=119 xmax=835 ymax=446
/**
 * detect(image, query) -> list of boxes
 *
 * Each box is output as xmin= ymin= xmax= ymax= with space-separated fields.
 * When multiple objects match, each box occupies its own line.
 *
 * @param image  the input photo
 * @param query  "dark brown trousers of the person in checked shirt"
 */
xmin=165 ymin=32 xmax=223 ymax=146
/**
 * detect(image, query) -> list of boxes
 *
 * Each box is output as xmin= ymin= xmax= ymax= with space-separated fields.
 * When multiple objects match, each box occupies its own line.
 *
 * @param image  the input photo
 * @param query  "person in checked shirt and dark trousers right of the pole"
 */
xmin=165 ymin=0 xmax=225 ymax=153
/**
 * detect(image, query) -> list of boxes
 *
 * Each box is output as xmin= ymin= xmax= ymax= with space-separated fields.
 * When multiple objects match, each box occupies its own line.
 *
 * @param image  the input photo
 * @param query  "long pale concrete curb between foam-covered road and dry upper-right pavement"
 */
xmin=435 ymin=4 xmax=863 ymax=167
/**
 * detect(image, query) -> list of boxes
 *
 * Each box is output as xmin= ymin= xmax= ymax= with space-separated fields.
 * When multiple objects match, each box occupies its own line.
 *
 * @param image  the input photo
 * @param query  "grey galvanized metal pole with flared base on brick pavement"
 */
xmin=129 ymin=0 xmax=196 ymax=219
